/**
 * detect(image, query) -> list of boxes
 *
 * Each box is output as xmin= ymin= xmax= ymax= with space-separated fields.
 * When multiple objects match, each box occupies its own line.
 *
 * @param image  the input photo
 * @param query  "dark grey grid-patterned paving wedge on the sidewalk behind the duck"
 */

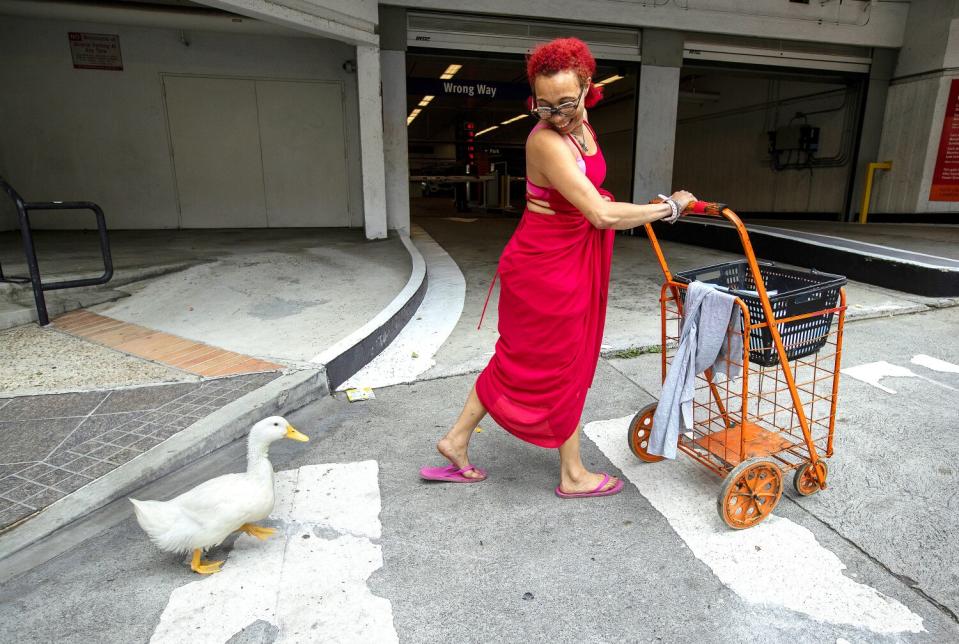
xmin=0 ymin=372 xmax=280 ymax=532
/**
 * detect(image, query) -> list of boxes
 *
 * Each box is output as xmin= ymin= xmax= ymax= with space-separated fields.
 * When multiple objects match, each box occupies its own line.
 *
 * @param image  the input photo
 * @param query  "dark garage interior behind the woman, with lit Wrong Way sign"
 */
xmin=407 ymin=51 xmax=638 ymax=216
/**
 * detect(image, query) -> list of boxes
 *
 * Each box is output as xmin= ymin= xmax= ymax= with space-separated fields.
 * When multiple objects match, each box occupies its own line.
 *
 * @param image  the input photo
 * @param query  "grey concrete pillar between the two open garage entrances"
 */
xmin=633 ymin=29 xmax=683 ymax=203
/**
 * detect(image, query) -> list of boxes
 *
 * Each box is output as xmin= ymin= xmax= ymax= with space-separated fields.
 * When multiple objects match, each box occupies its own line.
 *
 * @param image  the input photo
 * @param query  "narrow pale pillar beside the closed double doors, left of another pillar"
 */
xmin=356 ymin=45 xmax=387 ymax=239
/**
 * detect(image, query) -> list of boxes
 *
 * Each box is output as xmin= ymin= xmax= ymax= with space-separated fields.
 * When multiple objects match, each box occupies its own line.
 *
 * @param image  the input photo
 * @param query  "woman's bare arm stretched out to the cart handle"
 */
xmin=526 ymin=129 xmax=695 ymax=230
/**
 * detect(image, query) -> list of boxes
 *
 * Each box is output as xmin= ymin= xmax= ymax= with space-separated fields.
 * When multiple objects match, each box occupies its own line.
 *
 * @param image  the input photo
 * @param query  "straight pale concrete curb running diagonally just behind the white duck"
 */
xmin=0 ymin=369 xmax=329 ymax=565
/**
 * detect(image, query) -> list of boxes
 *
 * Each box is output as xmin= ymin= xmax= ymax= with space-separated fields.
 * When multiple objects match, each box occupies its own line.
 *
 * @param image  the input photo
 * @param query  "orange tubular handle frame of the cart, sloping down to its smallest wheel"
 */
xmin=646 ymin=199 xmax=828 ymax=472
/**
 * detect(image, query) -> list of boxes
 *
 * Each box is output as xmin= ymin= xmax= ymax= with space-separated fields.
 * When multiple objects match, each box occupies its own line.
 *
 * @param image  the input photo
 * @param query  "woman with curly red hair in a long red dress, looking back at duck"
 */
xmin=421 ymin=38 xmax=695 ymax=498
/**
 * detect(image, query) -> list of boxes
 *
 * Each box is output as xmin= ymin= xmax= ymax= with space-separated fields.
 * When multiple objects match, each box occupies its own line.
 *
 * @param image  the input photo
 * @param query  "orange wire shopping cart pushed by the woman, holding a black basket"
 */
xmin=628 ymin=202 xmax=846 ymax=529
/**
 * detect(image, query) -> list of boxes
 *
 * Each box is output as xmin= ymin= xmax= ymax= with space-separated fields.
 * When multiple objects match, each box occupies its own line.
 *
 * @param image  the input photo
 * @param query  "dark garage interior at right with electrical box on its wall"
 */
xmin=673 ymin=63 xmax=865 ymax=221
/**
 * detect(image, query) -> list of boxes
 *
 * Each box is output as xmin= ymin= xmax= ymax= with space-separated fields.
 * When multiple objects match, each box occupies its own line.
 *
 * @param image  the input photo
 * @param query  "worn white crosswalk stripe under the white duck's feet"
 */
xmin=150 ymin=461 xmax=398 ymax=644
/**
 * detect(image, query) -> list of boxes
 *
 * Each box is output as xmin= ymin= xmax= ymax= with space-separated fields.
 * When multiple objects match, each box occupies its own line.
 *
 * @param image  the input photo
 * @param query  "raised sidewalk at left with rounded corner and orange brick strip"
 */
xmin=0 ymin=229 xmax=424 ymax=558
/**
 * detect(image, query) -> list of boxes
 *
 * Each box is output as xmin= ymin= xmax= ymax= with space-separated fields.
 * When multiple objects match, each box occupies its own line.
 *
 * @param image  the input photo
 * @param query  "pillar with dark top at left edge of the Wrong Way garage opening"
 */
xmin=380 ymin=5 xmax=410 ymax=234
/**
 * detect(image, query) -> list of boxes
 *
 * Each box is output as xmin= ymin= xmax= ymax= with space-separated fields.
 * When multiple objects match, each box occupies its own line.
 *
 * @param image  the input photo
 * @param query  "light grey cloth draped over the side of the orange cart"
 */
xmin=646 ymin=282 xmax=743 ymax=458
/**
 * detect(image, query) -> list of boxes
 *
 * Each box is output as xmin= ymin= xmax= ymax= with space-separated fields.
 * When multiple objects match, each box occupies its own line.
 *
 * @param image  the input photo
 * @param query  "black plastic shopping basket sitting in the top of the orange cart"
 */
xmin=674 ymin=260 xmax=846 ymax=367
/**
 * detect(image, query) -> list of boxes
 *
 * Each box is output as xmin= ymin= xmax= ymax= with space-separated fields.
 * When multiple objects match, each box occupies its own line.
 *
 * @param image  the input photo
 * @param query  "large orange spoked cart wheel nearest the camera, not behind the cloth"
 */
xmin=716 ymin=458 xmax=783 ymax=530
